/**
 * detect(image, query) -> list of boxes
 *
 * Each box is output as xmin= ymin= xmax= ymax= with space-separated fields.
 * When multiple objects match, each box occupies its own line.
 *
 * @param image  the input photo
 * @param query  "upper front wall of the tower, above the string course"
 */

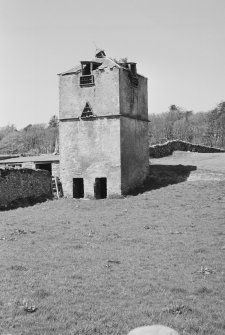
xmin=59 ymin=67 xmax=120 ymax=119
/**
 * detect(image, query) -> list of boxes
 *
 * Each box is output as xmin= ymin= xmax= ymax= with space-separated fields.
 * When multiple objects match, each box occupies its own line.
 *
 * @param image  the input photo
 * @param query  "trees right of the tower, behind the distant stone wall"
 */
xmin=149 ymin=101 xmax=225 ymax=148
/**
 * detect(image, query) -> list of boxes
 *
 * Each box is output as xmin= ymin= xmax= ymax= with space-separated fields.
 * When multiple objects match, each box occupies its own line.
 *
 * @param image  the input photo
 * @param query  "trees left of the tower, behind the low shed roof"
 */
xmin=0 ymin=115 xmax=59 ymax=155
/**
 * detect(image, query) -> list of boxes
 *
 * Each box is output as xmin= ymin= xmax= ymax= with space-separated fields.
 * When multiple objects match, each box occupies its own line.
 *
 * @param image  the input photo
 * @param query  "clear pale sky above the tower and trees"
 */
xmin=0 ymin=0 xmax=225 ymax=129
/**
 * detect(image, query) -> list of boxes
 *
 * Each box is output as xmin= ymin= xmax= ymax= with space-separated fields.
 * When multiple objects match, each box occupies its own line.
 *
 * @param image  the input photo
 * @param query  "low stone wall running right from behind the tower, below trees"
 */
xmin=149 ymin=140 xmax=225 ymax=158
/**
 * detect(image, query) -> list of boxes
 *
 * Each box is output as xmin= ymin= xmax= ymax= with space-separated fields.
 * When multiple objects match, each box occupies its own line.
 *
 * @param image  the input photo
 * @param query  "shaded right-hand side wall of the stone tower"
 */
xmin=120 ymin=69 xmax=149 ymax=194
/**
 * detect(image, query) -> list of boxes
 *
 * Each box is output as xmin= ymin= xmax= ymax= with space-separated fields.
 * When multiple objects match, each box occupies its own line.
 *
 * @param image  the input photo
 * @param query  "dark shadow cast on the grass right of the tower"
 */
xmin=132 ymin=165 xmax=197 ymax=195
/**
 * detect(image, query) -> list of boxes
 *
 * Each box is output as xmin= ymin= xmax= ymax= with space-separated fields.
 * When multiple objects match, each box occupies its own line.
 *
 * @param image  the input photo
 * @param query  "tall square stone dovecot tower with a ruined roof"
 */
xmin=59 ymin=50 xmax=149 ymax=199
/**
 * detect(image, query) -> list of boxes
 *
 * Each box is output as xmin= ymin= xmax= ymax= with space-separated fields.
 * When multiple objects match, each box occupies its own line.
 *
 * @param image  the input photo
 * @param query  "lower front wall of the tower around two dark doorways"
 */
xmin=60 ymin=117 xmax=121 ymax=197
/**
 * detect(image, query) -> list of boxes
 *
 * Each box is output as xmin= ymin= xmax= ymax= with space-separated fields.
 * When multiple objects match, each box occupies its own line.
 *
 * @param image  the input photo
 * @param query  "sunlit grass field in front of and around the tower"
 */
xmin=0 ymin=153 xmax=225 ymax=335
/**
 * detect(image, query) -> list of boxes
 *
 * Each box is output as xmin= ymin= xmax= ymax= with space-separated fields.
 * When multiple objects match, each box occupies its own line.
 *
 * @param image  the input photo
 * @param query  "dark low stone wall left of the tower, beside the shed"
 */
xmin=0 ymin=169 xmax=52 ymax=210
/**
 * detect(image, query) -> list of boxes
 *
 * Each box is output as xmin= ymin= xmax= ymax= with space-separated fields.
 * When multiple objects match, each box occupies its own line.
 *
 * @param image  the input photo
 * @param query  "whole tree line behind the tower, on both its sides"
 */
xmin=0 ymin=101 xmax=225 ymax=155
